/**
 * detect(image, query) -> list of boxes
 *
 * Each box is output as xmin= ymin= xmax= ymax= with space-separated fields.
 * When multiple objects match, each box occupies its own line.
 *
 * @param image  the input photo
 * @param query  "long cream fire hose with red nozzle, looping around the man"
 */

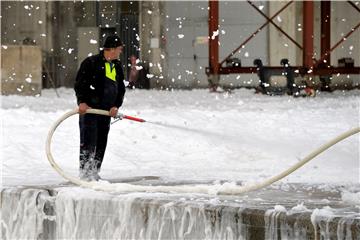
xmin=45 ymin=109 xmax=360 ymax=195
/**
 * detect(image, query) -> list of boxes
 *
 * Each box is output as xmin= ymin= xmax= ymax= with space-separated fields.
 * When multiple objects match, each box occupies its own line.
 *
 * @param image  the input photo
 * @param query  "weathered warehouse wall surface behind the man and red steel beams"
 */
xmin=1 ymin=1 xmax=360 ymax=93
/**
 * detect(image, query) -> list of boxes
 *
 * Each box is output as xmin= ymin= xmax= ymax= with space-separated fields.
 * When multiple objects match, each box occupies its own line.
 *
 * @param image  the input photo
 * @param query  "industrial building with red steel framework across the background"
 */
xmin=1 ymin=1 xmax=360 ymax=95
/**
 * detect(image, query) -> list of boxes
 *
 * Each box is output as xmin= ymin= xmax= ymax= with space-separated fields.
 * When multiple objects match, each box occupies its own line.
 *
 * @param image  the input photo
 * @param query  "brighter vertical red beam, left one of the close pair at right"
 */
xmin=303 ymin=1 xmax=314 ymax=68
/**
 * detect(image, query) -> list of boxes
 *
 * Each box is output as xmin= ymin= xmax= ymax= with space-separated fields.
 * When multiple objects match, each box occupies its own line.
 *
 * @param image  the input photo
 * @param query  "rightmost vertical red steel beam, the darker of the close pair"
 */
xmin=320 ymin=1 xmax=331 ymax=65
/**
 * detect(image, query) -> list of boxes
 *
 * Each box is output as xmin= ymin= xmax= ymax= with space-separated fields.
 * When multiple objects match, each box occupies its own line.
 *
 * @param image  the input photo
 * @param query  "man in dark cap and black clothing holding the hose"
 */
xmin=74 ymin=35 xmax=125 ymax=181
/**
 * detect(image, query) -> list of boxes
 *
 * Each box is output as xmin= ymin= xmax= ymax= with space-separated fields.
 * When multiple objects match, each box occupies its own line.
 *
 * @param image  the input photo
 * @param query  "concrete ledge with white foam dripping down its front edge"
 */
xmin=1 ymin=183 xmax=360 ymax=239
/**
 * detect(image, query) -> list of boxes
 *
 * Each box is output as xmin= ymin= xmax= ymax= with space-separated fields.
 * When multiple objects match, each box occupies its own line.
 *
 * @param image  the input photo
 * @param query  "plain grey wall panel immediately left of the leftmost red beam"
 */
xmin=164 ymin=2 xmax=208 ymax=87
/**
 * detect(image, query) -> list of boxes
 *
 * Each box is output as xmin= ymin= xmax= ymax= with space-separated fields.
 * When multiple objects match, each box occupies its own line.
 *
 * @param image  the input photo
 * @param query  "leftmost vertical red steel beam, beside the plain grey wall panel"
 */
xmin=209 ymin=0 xmax=219 ymax=75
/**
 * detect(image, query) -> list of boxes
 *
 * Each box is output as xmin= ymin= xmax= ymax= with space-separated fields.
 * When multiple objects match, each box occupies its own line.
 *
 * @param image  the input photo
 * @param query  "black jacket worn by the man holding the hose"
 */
xmin=74 ymin=51 xmax=125 ymax=110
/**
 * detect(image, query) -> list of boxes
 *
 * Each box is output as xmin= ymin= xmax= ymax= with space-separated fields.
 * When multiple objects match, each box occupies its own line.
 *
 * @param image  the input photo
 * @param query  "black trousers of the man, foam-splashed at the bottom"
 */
xmin=79 ymin=114 xmax=110 ymax=172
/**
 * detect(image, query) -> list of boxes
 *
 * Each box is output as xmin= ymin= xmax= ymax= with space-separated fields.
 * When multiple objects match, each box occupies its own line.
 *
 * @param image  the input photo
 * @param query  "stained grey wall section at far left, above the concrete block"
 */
xmin=1 ymin=1 xmax=77 ymax=87
